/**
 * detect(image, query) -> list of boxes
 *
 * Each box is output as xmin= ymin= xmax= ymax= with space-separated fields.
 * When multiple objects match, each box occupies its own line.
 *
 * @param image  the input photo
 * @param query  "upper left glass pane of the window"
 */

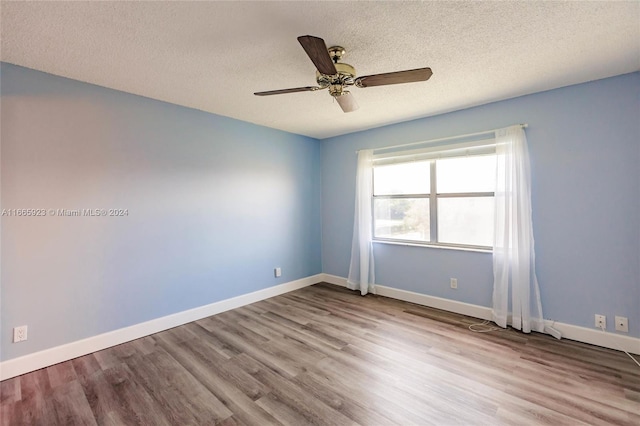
xmin=373 ymin=161 xmax=431 ymax=195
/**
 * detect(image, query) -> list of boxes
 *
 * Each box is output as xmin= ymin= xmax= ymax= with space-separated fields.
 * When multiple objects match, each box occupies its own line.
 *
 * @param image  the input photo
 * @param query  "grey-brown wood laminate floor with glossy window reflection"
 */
xmin=0 ymin=284 xmax=640 ymax=426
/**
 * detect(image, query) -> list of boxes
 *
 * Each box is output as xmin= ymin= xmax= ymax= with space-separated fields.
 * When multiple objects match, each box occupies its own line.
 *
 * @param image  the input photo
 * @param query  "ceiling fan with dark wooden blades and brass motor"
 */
xmin=254 ymin=35 xmax=432 ymax=112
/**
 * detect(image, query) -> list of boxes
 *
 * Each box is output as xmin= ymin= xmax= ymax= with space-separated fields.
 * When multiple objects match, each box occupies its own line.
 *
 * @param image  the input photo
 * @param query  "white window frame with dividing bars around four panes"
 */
xmin=371 ymin=140 xmax=496 ymax=252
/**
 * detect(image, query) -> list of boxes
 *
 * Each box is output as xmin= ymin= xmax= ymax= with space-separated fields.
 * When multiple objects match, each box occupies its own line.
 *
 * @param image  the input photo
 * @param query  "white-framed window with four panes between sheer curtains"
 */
xmin=373 ymin=144 xmax=496 ymax=248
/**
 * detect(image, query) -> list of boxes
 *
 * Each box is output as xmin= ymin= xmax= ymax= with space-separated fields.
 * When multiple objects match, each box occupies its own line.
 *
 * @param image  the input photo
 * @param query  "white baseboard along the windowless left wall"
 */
xmin=0 ymin=274 xmax=323 ymax=380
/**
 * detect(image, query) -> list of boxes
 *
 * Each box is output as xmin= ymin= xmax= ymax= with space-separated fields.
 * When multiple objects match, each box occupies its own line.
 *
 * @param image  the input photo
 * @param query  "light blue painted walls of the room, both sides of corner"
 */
xmin=0 ymin=64 xmax=640 ymax=360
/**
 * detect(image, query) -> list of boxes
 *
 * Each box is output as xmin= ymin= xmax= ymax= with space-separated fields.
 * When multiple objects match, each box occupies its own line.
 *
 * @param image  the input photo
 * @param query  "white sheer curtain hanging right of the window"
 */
xmin=493 ymin=126 xmax=544 ymax=333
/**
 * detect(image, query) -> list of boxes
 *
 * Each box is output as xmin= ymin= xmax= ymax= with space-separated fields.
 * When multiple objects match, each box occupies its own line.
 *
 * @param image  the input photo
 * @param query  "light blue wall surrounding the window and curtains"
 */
xmin=322 ymin=73 xmax=640 ymax=337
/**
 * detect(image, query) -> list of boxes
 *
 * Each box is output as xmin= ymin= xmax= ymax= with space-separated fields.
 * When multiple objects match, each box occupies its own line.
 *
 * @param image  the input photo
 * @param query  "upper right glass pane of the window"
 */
xmin=436 ymin=155 xmax=496 ymax=193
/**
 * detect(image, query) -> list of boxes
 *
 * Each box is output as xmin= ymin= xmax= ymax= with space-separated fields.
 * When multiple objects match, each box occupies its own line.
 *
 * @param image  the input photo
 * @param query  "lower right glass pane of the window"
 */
xmin=438 ymin=197 xmax=494 ymax=247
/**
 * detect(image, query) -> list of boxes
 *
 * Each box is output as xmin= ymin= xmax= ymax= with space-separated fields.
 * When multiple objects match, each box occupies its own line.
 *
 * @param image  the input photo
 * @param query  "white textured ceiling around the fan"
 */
xmin=0 ymin=1 xmax=640 ymax=138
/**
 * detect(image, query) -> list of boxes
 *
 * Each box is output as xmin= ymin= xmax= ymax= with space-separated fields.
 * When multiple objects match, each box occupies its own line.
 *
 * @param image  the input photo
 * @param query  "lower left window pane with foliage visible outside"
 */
xmin=373 ymin=198 xmax=431 ymax=241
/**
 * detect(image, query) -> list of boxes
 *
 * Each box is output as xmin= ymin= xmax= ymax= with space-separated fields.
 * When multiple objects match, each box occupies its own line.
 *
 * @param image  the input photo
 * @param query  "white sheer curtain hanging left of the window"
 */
xmin=347 ymin=149 xmax=375 ymax=296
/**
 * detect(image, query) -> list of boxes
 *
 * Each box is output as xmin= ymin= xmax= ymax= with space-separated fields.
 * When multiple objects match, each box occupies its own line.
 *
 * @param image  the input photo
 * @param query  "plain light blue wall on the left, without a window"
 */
xmin=0 ymin=64 xmax=321 ymax=360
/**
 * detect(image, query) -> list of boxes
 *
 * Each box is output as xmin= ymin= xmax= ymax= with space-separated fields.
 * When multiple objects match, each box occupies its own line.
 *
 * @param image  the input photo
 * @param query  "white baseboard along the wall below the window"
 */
xmin=320 ymin=274 xmax=640 ymax=354
